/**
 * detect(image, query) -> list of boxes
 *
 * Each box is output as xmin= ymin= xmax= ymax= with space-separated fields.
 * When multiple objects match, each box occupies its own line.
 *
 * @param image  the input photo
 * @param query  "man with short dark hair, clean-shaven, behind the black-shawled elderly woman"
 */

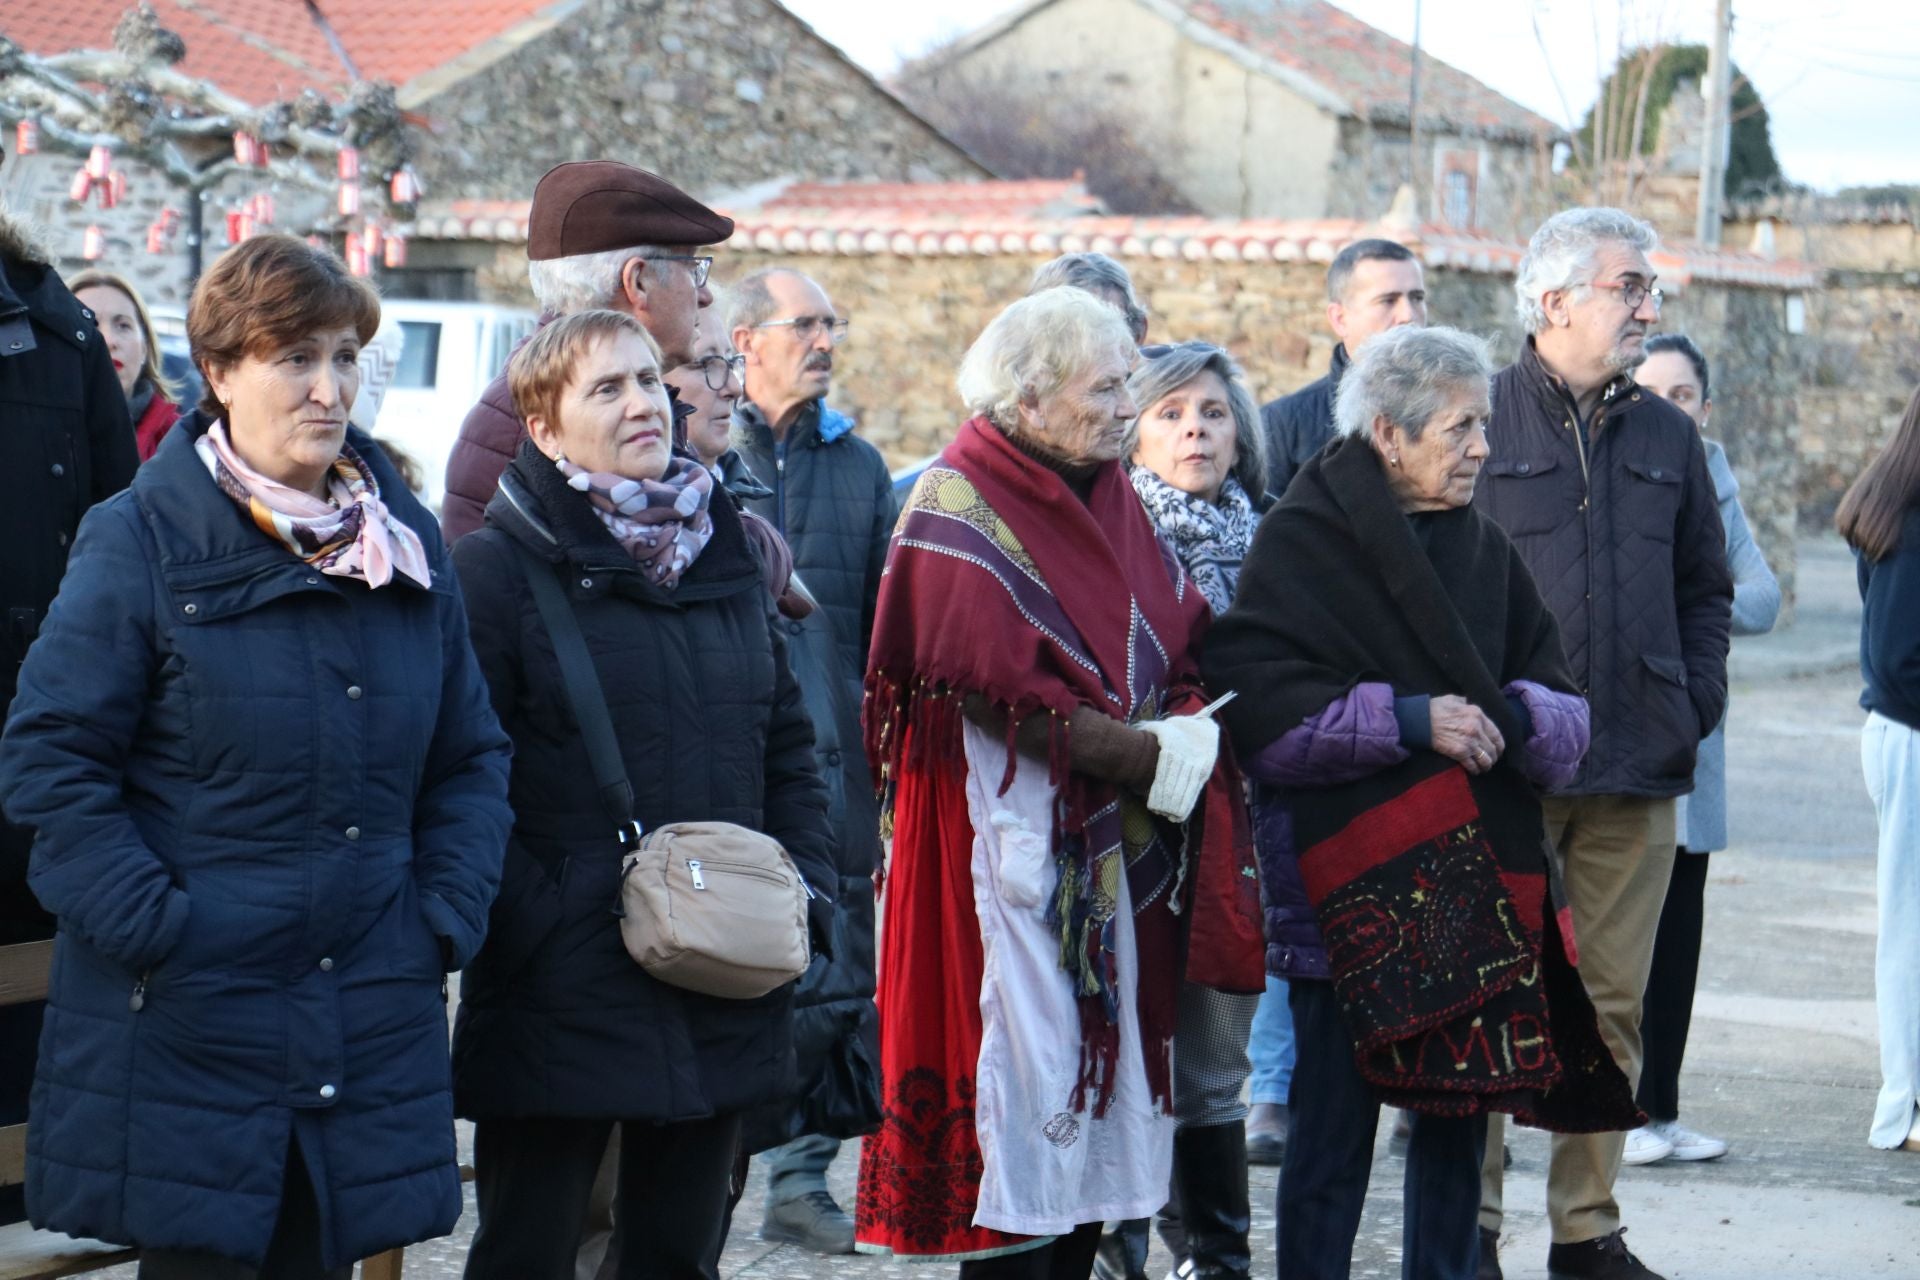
xmin=1260 ymin=240 xmax=1427 ymax=503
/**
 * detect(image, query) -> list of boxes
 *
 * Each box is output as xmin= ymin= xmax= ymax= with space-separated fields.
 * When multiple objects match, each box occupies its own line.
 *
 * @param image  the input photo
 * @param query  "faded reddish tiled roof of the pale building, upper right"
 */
xmin=1188 ymin=0 xmax=1563 ymax=138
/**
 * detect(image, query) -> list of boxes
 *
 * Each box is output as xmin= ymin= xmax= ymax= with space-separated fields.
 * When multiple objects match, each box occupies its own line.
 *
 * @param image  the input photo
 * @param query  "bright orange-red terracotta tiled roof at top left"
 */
xmin=0 ymin=0 xmax=551 ymax=106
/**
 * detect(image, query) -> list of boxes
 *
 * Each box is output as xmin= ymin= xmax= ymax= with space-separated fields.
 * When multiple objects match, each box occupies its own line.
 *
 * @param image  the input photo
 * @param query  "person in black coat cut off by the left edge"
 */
xmin=0 ymin=200 xmax=140 ymax=1222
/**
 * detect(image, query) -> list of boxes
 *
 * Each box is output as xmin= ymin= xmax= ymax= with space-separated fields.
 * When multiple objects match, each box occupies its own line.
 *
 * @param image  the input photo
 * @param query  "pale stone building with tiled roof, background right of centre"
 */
xmin=897 ymin=0 xmax=1563 ymax=236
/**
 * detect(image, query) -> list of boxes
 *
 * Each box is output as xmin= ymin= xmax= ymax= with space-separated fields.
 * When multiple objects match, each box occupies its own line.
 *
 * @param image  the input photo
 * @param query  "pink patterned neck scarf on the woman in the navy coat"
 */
xmin=194 ymin=422 xmax=432 ymax=587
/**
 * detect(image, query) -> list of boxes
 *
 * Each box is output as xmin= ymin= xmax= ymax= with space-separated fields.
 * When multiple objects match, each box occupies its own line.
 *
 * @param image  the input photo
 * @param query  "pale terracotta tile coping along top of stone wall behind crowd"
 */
xmin=411 ymin=201 xmax=1818 ymax=290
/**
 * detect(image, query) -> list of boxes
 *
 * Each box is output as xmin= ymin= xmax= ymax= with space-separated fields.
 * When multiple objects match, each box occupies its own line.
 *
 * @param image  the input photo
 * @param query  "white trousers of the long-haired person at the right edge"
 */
xmin=1860 ymin=712 xmax=1920 ymax=1150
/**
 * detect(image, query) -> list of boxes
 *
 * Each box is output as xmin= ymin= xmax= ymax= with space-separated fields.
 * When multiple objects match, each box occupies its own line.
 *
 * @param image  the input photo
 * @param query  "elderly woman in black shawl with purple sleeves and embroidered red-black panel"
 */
xmin=1206 ymin=328 xmax=1636 ymax=1280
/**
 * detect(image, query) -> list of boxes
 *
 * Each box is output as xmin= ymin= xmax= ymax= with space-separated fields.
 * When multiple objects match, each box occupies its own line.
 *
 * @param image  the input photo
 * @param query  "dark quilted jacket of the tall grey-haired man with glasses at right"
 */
xmin=1473 ymin=340 xmax=1734 ymax=796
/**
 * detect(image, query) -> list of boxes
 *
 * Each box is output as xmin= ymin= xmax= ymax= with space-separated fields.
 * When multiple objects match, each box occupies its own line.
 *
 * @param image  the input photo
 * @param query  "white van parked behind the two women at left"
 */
xmin=374 ymin=297 xmax=538 ymax=514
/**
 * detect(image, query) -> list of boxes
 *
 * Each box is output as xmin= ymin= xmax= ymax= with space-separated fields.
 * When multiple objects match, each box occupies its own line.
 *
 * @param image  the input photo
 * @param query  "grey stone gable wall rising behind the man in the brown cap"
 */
xmin=409 ymin=0 xmax=975 ymax=200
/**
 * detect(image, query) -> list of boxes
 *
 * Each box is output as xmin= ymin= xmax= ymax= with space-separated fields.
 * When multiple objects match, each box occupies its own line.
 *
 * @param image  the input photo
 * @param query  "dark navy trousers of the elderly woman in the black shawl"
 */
xmin=1277 ymin=979 xmax=1486 ymax=1280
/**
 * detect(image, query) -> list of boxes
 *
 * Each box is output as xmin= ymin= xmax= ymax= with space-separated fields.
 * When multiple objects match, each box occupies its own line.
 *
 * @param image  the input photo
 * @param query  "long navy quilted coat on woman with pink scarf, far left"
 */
xmin=0 ymin=426 xmax=511 ymax=1267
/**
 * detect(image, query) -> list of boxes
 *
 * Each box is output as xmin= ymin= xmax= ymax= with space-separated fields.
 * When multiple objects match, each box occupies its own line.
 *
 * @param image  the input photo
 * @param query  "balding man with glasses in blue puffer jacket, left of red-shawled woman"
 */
xmin=730 ymin=269 xmax=899 ymax=1253
